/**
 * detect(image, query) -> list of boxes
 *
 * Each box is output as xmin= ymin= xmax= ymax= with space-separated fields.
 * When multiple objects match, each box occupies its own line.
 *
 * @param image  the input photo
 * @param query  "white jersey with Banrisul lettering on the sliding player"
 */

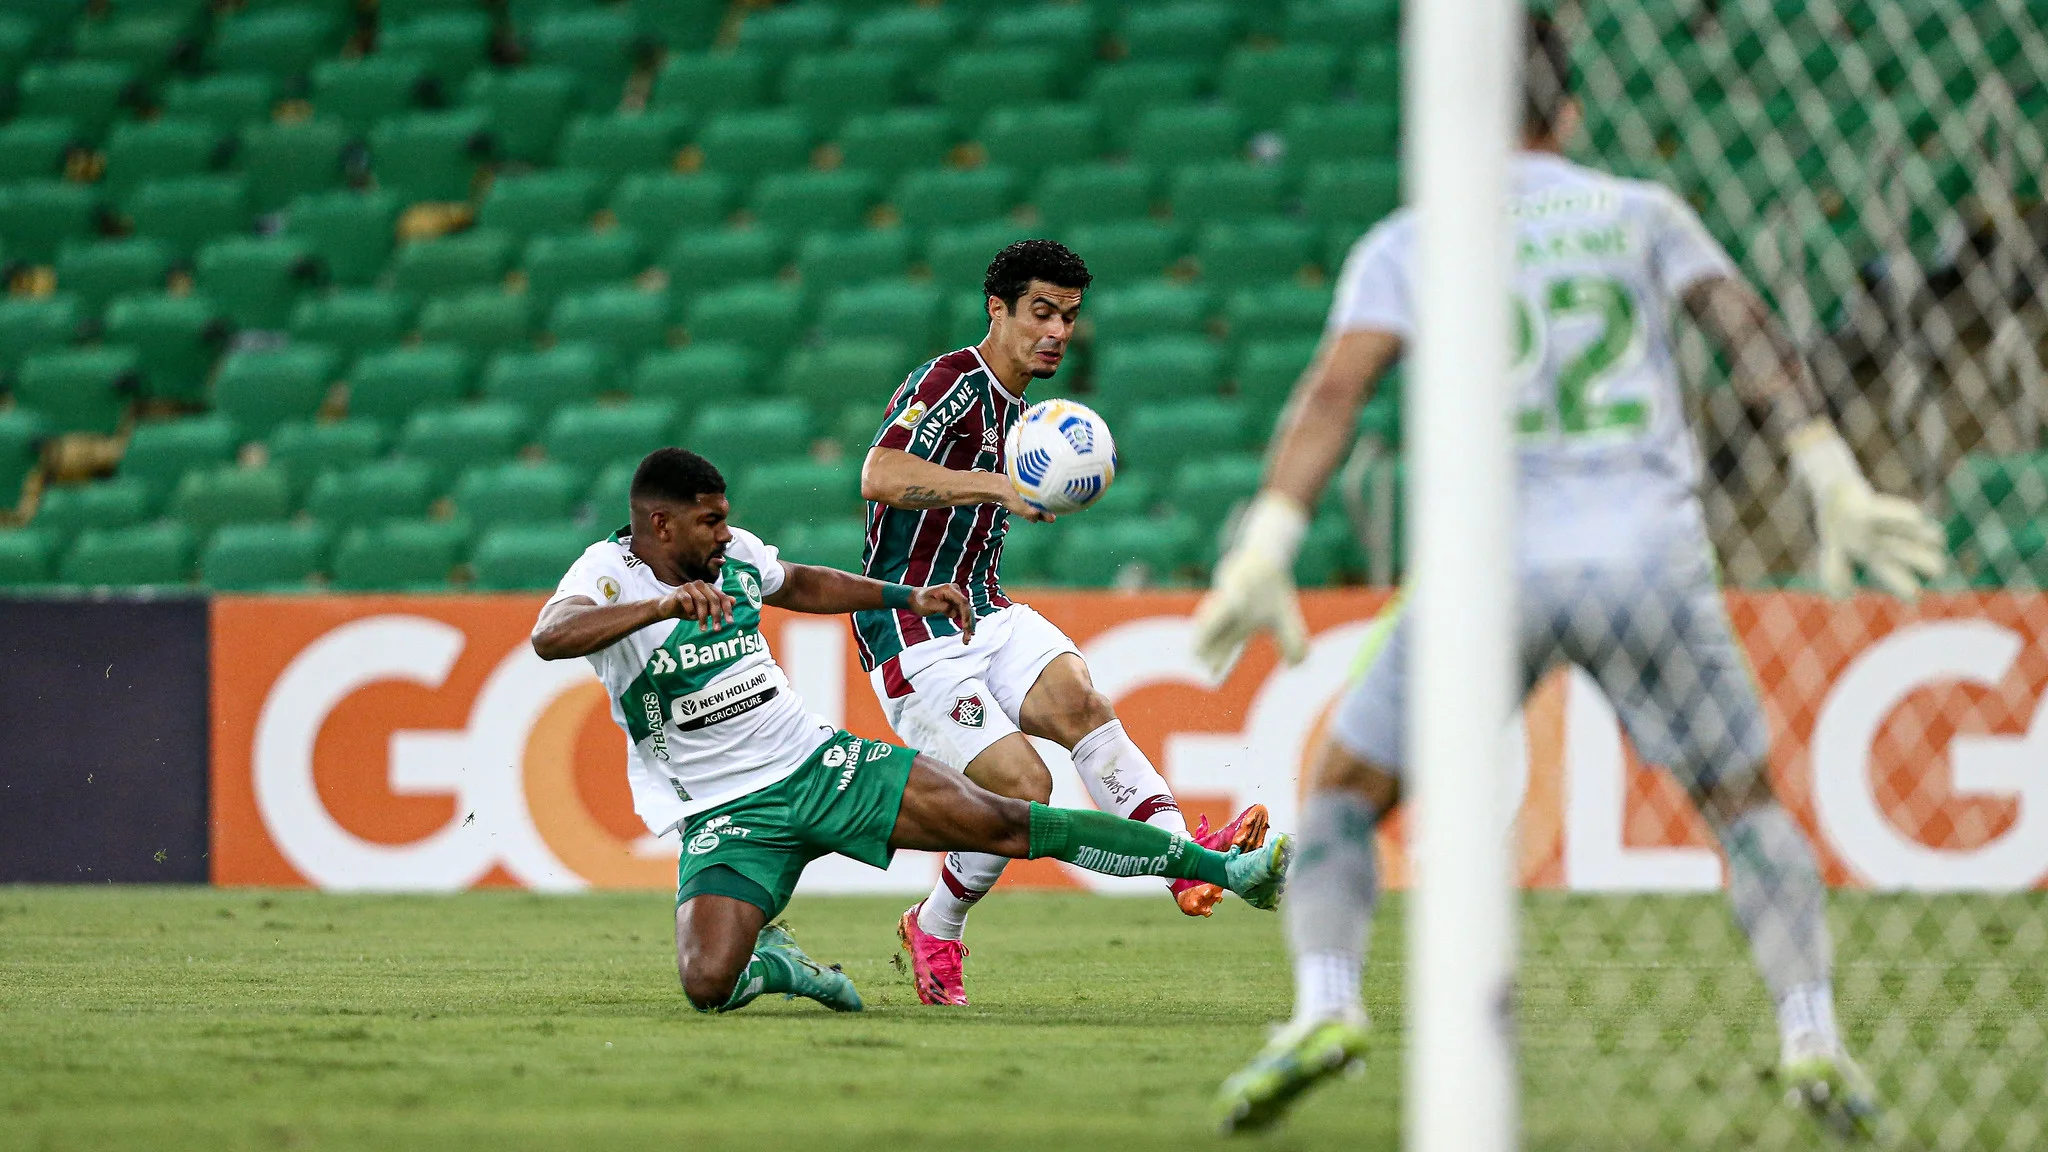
xmin=549 ymin=529 xmax=834 ymax=836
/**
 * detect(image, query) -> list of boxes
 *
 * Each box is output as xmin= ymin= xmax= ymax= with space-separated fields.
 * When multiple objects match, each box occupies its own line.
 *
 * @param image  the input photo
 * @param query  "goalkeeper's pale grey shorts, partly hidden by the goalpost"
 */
xmin=1331 ymin=524 xmax=1769 ymax=795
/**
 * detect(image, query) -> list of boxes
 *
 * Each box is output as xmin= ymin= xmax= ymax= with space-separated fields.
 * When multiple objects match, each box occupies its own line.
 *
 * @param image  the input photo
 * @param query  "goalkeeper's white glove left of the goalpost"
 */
xmin=1194 ymin=492 xmax=1309 ymax=681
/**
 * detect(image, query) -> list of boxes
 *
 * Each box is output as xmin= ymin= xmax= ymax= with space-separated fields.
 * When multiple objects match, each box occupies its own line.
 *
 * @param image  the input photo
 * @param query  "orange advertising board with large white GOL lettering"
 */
xmin=211 ymin=590 xmax=2048 ymax=892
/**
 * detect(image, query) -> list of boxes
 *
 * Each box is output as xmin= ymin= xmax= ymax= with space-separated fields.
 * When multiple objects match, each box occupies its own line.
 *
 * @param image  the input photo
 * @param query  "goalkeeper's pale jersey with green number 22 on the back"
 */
xmin=1329 ymin=152 xmax=1737 ymax=562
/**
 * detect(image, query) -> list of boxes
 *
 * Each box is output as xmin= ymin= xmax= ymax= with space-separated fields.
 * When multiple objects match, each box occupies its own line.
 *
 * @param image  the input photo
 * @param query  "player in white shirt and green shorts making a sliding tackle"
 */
xmin=532 ymin=449 xmax=1288 ymax=1013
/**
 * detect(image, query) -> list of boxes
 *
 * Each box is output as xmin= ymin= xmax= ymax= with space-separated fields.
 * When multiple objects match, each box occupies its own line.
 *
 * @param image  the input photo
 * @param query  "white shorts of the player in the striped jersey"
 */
xmin=868 ymin=605 xmax=1081 ymax=769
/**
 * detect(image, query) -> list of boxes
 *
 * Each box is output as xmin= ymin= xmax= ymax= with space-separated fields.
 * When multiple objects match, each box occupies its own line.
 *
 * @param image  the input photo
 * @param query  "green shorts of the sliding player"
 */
xmin=676 ymin=732 xmax=918 ymax=920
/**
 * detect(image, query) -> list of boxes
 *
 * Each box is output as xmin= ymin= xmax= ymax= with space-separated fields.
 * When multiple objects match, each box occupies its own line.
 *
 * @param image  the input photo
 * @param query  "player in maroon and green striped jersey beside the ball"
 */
xmin=854 ymin=240 xmax=1266 ymax=1004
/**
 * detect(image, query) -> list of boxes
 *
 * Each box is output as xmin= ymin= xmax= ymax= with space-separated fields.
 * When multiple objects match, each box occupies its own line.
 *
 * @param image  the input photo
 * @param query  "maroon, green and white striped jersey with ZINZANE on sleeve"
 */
xmin=854 ymin=348 xmax=1024 ymax=670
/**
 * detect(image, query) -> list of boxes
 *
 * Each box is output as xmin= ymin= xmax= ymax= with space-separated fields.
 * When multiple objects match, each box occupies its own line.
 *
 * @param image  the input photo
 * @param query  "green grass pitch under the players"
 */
xmin=0 ymin=888 xmax=2048 ymax=1152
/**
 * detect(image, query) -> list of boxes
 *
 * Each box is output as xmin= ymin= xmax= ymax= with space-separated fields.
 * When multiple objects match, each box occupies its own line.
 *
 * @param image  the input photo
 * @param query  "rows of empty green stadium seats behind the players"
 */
xmin=0 ymin=0 xmax=2042 ymax=588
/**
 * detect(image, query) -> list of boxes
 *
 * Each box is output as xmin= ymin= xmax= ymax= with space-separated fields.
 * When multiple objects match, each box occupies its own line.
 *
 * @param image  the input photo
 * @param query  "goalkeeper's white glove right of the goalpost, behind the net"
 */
xmin=1788 ymin=420 xmax=1948 ymax=596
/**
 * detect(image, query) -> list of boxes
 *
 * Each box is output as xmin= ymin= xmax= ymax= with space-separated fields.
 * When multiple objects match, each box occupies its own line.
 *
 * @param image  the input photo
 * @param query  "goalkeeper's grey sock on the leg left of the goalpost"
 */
xmin=1284 ymin=789 xmax=1378 ymax=1023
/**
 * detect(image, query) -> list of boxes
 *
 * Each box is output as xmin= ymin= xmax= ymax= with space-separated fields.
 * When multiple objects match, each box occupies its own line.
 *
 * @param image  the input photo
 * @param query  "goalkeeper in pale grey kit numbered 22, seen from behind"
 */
xmin=1196 ymin=18 xmax=1942 ymax=1132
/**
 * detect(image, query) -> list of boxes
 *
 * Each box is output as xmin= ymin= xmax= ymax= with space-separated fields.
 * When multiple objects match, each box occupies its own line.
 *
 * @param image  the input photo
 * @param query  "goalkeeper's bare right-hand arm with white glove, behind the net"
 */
xmin=1679 ymin=275 xmax=1946 ymax=596
